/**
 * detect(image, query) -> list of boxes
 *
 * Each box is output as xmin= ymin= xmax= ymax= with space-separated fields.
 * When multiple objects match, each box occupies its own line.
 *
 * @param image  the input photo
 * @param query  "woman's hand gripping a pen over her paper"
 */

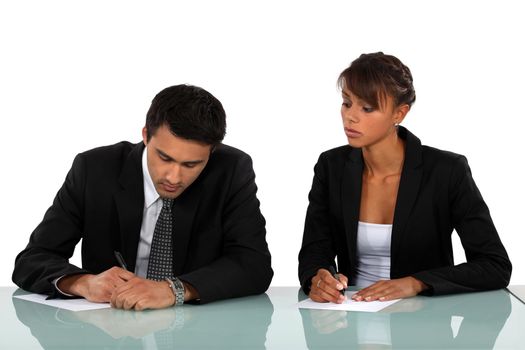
xmin=308 ymin=269 xmax=348 ymax=304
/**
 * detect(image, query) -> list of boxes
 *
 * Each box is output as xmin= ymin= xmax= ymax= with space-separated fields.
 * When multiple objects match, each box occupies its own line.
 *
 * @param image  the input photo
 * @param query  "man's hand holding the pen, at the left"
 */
xmin=57 ymin=267 xmax=135 ymax=303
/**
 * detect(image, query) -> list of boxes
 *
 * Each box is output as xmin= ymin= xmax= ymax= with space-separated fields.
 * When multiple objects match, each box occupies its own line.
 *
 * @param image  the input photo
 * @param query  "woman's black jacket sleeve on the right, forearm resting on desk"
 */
xmin=413 ymin=156 xmax=512 ymax=295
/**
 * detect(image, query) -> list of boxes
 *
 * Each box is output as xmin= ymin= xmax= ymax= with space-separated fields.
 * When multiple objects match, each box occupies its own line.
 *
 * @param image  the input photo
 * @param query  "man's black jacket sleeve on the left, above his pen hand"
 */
xmin=12 ymin=155 xmax=87 ymax=296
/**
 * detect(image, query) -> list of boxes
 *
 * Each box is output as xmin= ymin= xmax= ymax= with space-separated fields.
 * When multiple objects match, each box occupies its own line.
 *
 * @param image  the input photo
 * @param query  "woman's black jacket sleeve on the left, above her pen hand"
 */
xmin=299 ymin=155 xmax=336 ymax=294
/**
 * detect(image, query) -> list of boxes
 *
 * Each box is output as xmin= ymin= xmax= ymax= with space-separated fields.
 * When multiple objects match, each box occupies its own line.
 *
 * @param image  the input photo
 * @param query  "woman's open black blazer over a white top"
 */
xmin=299 ymin=126 xmax=512 ymax=294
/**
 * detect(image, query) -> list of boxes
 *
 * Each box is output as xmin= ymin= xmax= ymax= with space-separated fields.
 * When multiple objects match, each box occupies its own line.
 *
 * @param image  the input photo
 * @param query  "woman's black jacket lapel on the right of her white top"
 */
xmin=390 ymin=126 xmax=423 ymax=278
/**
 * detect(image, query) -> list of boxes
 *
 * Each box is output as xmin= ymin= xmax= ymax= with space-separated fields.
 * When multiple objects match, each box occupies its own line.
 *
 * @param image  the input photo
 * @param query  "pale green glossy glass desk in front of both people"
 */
xmin=0 ymin=287 xmax=525 ymax=349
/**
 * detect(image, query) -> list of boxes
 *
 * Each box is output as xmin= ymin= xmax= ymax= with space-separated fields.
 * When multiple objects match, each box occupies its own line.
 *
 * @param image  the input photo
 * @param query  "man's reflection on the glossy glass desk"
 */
xmin=12 ymin=290 xmax=273 ymax=350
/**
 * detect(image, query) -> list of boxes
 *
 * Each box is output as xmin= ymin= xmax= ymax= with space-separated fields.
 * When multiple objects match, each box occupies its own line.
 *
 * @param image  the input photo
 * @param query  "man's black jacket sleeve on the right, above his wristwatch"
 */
xmin=179 ymin=155 xmax=273 ymax=303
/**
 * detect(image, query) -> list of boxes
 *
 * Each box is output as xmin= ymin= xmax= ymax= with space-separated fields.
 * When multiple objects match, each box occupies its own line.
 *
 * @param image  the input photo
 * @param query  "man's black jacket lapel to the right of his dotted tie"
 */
xmin=172 ymin=183 xmax=202 ymax=276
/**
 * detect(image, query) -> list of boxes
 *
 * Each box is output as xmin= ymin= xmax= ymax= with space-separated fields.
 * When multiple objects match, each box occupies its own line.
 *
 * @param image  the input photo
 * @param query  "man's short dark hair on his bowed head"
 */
xmin=146 ymin=85 xmax=226 ymax=145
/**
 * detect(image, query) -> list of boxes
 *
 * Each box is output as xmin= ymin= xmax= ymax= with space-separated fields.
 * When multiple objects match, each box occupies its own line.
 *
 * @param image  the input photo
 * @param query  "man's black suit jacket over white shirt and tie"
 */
xmin=13 ymin=142 xmax=273 ymax=303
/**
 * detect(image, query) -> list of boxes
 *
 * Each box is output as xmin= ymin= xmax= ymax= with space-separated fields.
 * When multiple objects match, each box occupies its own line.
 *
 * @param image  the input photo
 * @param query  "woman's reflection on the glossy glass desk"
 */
xmin=299 ymin=290 xmax=511 ymax=349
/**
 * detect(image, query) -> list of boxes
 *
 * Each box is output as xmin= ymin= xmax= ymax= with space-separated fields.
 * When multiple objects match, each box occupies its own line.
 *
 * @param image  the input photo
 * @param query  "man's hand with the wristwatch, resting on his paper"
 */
xmin=111 ymin=277 xmax=175 ymax=310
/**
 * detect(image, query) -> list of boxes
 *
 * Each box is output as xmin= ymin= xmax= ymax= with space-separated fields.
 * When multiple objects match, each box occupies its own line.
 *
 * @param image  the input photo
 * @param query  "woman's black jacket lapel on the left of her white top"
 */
xmin=341 ymin=148 xmax=363 ymax=271
